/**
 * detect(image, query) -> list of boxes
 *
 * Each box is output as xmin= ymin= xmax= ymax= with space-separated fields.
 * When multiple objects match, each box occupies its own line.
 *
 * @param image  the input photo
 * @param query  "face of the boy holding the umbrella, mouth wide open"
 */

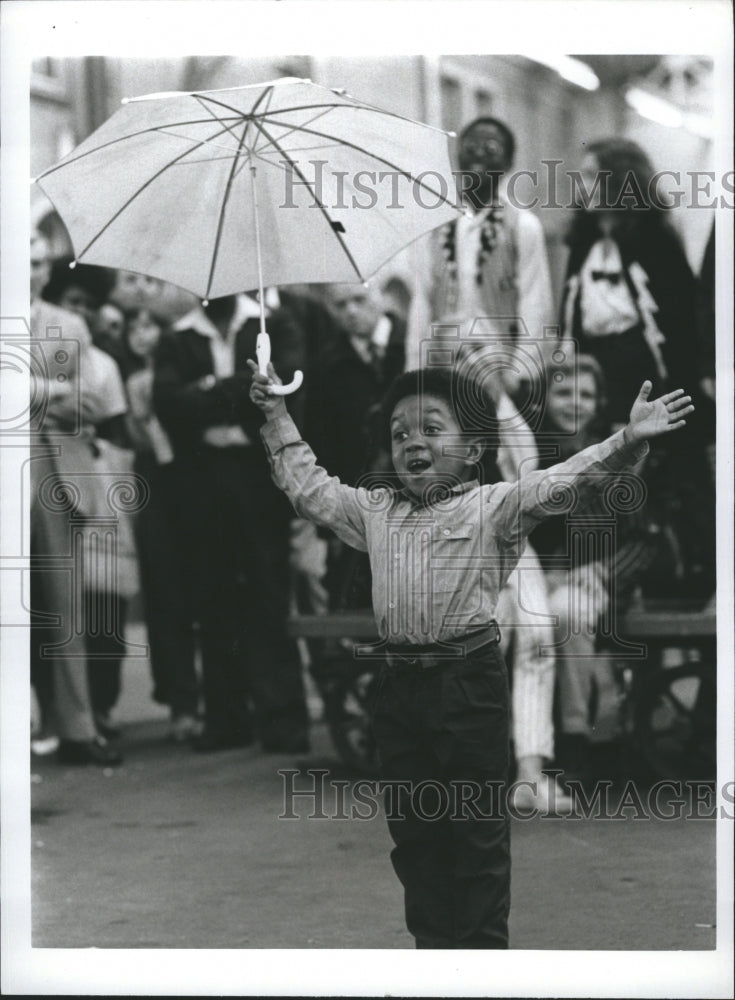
xmin=390 ymin=395 xmax=482 ymax=499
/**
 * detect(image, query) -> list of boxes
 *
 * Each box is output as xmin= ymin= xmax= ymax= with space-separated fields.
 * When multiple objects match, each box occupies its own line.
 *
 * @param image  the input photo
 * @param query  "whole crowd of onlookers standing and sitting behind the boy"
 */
xmin=31 ymin=118 xmax=715 ymax=796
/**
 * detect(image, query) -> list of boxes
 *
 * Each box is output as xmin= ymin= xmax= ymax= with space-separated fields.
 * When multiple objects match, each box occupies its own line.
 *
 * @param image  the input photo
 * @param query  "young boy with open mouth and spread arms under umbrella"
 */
xmin=249 ymin=362 xmax=693 ymax=948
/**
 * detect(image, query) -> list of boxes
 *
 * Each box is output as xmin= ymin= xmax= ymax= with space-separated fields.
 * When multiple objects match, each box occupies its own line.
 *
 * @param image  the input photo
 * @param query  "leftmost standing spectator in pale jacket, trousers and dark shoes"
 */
xmin=31 ymin=234 xmax=122 ymax=766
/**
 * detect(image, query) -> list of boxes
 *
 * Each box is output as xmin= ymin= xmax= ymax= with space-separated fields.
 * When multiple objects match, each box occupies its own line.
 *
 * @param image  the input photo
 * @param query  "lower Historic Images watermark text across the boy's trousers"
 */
xmin=278 ymin=768 xmax=735 ymax=822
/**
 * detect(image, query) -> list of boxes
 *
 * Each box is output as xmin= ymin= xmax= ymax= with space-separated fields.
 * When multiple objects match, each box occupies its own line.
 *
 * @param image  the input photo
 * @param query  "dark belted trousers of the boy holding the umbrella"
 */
xmin=374 ymin=645 xmax=510 ymax=948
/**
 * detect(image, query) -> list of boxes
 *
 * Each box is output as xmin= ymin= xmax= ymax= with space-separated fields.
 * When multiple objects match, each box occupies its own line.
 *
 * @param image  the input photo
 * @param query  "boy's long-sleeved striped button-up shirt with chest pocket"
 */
xmin=261 ymin=416 xmax=648 ymax=644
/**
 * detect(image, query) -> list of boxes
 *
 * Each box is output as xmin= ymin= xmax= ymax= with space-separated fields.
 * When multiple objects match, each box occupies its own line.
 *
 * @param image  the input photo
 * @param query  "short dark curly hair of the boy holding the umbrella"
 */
xmin=380 ymin=366 xmax=498 ymax=469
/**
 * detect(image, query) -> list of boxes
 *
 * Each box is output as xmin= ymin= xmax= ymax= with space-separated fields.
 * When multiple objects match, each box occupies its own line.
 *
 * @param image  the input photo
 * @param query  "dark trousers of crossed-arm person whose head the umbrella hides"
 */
xmin=192 ymin=448 xmax=307 ymax=745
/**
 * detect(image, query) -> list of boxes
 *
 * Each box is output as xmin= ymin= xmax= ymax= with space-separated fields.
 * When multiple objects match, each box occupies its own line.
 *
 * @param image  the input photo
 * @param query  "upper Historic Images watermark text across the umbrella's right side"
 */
xmin=278 ymin=159 xmax=735 ymax=211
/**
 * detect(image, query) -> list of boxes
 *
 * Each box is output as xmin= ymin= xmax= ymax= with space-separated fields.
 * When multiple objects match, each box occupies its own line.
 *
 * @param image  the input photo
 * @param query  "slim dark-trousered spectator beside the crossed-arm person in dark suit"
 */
xmin=123 ymin=308 xmax=200 ymax=742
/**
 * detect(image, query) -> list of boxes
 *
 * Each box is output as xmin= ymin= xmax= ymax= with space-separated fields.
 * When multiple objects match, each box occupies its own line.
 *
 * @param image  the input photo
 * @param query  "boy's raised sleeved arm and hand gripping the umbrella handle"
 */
xmin=248 ymin=361 xmax=370 ymax=552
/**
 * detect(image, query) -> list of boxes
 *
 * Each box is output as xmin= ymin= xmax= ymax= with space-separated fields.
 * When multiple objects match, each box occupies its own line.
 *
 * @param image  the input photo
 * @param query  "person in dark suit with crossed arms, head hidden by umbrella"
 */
xmin=154 ymin=295 xmax=308 ymax=752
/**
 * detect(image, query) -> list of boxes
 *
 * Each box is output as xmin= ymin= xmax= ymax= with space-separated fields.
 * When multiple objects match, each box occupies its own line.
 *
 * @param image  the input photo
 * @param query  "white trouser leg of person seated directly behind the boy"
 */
xmin=496 ymin=545 xmax=554 ymax=759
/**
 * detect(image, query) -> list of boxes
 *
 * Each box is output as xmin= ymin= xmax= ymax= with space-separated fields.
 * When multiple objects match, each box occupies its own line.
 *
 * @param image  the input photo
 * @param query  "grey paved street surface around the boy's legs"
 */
xmin=32 ymin=632 xmax=715 ymax=950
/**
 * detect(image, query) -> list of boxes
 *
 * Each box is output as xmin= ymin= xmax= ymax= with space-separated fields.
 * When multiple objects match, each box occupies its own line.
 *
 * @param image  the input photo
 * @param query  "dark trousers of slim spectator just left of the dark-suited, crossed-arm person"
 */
xmin=135 ymin=456 xmax=199 ymax=716
